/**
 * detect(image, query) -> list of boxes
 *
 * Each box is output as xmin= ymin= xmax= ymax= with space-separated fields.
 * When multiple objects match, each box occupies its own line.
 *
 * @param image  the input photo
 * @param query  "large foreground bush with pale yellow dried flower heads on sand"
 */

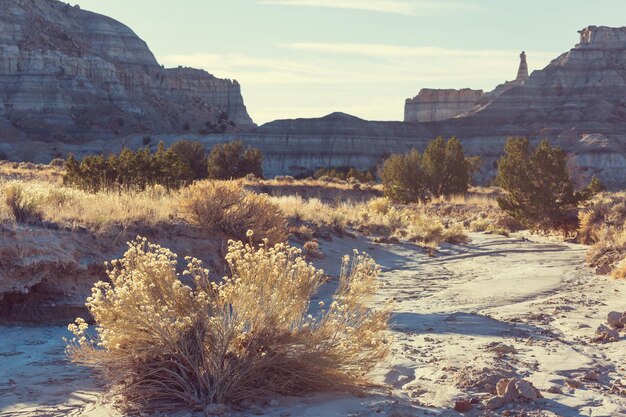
xmin=68 ymin=238 xmax=389 ymax=412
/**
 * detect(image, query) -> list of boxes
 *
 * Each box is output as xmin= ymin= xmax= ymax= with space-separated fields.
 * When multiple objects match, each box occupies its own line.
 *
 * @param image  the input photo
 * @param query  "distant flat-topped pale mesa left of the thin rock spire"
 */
xmin=404 ymin=88 xmax=484 ymax=123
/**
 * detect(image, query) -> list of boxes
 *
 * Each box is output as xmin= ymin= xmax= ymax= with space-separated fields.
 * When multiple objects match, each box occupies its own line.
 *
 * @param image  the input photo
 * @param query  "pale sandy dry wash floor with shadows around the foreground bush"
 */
xmin=0 ymin=234 xmax=626 ymax=417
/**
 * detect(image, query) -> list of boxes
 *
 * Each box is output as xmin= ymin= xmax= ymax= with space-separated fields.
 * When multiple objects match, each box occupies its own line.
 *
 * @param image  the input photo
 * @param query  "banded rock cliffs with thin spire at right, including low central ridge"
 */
xmin=224 ymin=26 xmax=626 ymax=189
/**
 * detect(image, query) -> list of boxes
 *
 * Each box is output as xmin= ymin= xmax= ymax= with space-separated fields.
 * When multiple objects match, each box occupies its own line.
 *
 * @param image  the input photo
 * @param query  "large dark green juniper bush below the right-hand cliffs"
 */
xmin=497 ymin=138 xmax=599 ymax=230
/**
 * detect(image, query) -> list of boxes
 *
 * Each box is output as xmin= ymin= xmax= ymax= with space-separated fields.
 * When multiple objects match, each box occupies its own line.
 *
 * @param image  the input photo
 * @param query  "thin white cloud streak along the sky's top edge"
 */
xmin=257 ymin=0 xmax=483 ymax=16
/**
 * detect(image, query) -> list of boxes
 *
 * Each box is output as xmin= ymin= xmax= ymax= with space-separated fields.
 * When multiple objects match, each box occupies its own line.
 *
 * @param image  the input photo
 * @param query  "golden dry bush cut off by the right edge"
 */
xmin=578 ymin=193 xmax=626 ymax=278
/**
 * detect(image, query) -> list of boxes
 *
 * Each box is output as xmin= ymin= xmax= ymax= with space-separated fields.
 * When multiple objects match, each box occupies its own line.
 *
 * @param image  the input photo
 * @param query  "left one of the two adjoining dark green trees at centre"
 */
xmin=379 ymin=149 xmax=427 ymax=204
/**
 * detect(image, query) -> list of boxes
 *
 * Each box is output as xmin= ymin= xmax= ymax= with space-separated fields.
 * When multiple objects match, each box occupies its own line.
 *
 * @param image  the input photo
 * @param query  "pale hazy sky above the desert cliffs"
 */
xmin=78 ymin=0 xmax=626 ymax=124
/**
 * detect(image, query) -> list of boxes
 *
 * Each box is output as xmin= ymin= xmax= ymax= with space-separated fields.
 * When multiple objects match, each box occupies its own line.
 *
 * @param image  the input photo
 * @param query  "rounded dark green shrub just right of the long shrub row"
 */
xmin=208 ymin=141 xmax=263 ymax=180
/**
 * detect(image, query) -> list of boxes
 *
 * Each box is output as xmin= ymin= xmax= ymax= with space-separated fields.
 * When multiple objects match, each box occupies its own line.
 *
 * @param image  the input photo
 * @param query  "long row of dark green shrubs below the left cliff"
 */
xmin=63 ymin=142 xmax=193 ymax=192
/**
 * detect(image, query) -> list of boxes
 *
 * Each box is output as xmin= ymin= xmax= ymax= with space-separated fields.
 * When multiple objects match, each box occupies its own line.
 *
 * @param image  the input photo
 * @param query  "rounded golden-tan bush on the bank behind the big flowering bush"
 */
xmin=180 ymin=181 xmax=287 ymax=244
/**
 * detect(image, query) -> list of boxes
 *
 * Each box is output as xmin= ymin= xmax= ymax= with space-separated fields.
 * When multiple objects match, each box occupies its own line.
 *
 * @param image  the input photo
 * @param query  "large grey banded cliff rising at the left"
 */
xmin=0 ymin=0 xmax=253 ymax=142
